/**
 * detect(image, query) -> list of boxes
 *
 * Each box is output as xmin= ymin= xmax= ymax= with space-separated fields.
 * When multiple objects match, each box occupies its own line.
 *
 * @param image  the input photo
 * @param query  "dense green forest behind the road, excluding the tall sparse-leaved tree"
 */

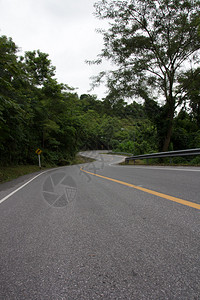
xmin=0 ymin=30 xmax=200 ymax=166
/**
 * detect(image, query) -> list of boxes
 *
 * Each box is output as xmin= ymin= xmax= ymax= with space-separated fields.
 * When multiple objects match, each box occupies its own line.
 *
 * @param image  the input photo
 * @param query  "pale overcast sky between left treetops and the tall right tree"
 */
xmin=0 ymin=0 xmax=109 ymax=99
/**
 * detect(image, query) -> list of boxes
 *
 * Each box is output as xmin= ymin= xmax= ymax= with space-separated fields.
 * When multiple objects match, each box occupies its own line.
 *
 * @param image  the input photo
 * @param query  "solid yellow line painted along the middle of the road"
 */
xmin=80 ymin=168 xmax=200 ymax=209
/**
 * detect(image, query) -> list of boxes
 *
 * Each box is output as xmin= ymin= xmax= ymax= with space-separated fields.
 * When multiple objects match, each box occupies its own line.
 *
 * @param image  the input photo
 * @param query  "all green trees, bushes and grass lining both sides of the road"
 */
xmin=0 ymin=0 xmax=200 ymax=180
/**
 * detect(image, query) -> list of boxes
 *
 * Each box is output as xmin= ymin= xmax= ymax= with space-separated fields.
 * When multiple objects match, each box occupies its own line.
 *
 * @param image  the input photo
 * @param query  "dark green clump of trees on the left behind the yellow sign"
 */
xmin=0 ymin=36 xmax=79 ymax=165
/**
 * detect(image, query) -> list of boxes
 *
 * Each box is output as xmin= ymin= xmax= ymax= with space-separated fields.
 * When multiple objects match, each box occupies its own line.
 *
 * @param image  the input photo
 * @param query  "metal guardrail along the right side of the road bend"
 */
xmin=125 ymin=148 xmax=200 ymax=163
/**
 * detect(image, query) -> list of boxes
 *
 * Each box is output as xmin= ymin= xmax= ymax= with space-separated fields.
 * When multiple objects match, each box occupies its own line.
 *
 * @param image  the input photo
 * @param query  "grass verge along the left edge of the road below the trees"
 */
xmin=0 ymin=155 xmax=94 ymax=183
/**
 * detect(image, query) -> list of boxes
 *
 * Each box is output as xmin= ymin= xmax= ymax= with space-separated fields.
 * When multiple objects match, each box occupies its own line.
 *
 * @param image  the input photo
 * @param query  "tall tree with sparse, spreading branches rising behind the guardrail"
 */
xmin=93 ymin=0 xmax=200 ymax=151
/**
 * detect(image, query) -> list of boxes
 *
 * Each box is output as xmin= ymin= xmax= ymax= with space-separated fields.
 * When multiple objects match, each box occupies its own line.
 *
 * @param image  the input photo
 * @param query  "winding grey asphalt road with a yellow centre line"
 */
xmin=0 ymin=152 xmax=200 ymax=300
